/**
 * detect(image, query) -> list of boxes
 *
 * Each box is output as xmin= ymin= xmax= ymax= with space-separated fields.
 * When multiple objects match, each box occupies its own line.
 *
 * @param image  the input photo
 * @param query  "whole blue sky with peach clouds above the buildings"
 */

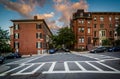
xmin=0 ymin=0 xmax=120 ymax=33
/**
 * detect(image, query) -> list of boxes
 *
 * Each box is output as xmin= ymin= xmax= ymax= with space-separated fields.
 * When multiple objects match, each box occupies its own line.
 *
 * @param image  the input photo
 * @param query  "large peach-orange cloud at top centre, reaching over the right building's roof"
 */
xmin=53 ymin=0 xmax=88 ymax=25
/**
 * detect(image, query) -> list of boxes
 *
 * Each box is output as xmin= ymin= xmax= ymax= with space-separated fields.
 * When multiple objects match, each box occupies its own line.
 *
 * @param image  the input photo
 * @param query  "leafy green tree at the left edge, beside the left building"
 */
xmin=0 ymin=27 xmax=11 ymax=52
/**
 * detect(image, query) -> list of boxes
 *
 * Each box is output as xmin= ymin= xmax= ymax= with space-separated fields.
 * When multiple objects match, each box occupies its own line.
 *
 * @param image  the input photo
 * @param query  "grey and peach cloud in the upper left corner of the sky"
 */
xmin=0 ymin=0 xmax=46 ymax=17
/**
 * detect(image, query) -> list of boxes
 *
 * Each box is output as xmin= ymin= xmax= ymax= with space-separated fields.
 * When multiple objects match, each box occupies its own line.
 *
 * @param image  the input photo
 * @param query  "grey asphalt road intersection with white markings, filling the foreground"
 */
xmin=0 ymin=52 xmax=120 ymax=79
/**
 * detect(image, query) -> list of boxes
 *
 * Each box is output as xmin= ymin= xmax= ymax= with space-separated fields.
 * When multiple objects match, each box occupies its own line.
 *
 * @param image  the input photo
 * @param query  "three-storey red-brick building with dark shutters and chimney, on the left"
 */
xmin=10 ymin=16 xmax=52 ymax=55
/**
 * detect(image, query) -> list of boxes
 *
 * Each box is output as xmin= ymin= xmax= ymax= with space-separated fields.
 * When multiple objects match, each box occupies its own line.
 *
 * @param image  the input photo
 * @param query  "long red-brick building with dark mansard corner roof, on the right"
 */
xmin=71 ymin=10 xmax=120 ymax=49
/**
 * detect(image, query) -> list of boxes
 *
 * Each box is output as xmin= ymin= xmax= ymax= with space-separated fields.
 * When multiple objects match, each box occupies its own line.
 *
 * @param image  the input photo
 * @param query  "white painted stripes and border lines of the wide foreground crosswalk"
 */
xmin=0 ymin=61 xmax=120 ymax=76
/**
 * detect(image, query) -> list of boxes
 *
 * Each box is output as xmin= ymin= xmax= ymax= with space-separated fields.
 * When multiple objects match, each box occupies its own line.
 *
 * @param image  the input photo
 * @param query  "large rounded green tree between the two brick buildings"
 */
xmin=53 ymin=27 xmax=75 ymax=48
